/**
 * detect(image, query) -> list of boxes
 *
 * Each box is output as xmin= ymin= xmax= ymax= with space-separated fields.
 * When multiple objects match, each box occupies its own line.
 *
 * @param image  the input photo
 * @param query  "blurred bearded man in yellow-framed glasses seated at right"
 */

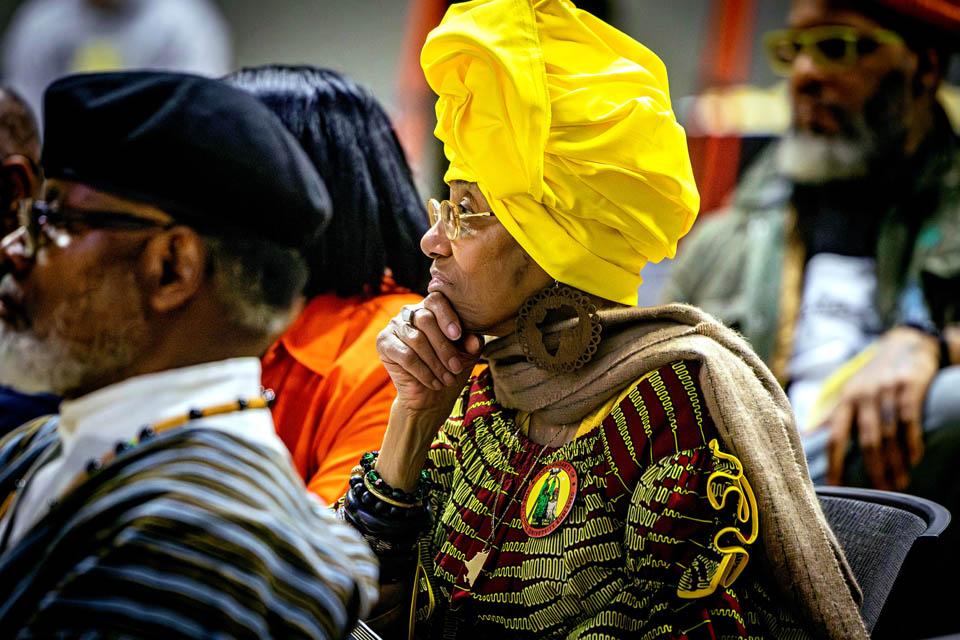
xmin=666 ymin=0 xmax=960 ymax=608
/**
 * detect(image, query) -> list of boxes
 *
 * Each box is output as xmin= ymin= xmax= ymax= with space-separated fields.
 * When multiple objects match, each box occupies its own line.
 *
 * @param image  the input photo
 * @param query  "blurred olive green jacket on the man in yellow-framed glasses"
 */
xmin=663 ymin=112 xmax=960 ymax=364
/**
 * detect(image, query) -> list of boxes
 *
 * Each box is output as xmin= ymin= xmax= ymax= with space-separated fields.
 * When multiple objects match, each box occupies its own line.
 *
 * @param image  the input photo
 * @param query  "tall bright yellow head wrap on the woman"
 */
xmin=420 ymin=0 xmax=700 ymax=304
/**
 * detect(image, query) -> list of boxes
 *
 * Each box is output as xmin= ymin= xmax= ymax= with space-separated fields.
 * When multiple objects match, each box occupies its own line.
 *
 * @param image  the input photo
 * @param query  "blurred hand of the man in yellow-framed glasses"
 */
xmin=827 ymin=327 xmax=940 ymax=490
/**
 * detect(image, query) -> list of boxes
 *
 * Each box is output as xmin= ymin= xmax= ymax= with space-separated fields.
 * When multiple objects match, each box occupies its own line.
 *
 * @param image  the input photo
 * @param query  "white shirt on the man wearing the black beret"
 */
xmin=0 ymin=358 xmax=289 ymax=549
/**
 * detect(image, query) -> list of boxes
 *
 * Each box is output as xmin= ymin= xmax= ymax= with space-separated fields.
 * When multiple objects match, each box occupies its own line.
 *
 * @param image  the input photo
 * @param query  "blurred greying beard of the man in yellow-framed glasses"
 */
xmin=777 ymin=131 xmax=877 ymax=185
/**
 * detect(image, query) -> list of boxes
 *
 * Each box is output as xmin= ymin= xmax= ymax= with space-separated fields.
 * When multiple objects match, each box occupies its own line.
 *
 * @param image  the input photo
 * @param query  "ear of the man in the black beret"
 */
xmin=140 ymin=226 xmax=207 ymax=313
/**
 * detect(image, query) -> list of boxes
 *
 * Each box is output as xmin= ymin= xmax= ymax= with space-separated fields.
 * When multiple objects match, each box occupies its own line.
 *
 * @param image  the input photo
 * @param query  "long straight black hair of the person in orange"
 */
xmin=226 ymin=65 xmax=429 ymax=297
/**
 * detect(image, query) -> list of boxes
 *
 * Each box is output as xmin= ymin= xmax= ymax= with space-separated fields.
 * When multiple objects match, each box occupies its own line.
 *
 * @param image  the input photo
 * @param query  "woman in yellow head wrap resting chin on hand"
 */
xmin=340 ymin=0 xmax=866 ymax=638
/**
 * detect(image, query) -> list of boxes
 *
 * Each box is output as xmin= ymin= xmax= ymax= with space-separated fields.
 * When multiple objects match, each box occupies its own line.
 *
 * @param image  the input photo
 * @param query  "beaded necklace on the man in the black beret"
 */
xmin=0 ymin=389 xmax=276 ymax=528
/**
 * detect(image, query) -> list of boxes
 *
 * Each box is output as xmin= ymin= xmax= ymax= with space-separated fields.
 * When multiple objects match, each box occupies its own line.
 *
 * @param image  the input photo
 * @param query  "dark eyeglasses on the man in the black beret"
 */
xmin=0 ymin=199 xmax=176 ymax=258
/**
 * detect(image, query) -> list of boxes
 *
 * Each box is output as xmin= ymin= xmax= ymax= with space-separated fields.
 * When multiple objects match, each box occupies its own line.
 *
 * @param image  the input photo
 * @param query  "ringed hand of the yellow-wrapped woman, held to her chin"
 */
xmin=377 ymin=293 xmax=483 ymax=418
